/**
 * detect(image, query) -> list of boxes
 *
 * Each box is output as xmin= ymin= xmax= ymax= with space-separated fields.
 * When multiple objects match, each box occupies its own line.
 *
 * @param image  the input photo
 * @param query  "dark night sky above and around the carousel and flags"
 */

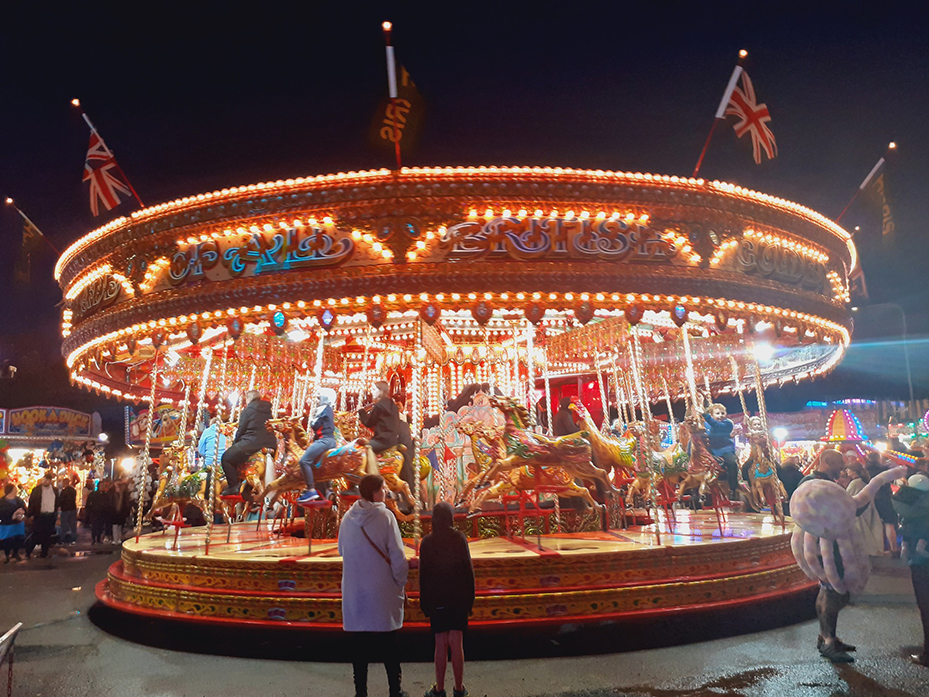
xmin=0 ymin=1 xmax=929 ymax=408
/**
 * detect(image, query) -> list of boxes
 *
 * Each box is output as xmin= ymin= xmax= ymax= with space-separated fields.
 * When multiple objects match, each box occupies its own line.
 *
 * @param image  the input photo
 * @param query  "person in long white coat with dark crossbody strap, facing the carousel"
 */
xmin=339 ymin=474 xmax=409 ymax=697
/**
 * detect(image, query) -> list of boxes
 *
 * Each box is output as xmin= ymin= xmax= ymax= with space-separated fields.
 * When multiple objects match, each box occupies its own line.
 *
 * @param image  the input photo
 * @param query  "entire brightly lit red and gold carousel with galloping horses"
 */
xmin=56 ymin=167 xmax=857 ymax=630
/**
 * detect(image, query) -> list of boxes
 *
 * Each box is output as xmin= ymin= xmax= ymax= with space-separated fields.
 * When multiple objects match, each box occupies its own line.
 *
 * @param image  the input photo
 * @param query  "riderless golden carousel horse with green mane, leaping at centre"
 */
xmin=482 ymin=395 xmax=615 ymax=492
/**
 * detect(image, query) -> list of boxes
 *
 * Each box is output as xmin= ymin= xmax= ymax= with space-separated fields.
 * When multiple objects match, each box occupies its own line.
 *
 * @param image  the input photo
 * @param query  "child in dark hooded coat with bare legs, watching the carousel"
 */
xmin=419 ymin=501 xmax=474 ymax=697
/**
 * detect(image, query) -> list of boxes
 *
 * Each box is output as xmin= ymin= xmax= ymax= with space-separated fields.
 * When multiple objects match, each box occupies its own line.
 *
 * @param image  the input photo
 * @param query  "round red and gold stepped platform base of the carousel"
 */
xmin=97 ymin=511 xmax=812 ymax=632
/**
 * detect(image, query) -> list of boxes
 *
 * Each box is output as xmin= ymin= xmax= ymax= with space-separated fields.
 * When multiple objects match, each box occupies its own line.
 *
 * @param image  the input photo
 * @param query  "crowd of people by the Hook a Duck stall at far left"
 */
xmin=0 ymin=469 xmax=133 ymax=564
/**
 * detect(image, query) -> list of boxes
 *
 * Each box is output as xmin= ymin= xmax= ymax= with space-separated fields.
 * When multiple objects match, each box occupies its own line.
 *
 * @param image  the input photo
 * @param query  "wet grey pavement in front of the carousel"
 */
xmin=0 ymin=548 xmax=929 ymax=697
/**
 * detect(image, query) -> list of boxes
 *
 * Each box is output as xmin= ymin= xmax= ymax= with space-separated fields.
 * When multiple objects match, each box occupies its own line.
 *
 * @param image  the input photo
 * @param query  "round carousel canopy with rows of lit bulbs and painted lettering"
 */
xmin=56 ymin=167 xmax=857 ymax=408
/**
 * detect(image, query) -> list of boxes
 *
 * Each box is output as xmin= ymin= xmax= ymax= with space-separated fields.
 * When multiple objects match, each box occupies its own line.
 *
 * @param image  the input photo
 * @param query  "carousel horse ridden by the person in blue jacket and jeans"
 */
xmin=265 ymin=417 xmax=413 ymax=521
